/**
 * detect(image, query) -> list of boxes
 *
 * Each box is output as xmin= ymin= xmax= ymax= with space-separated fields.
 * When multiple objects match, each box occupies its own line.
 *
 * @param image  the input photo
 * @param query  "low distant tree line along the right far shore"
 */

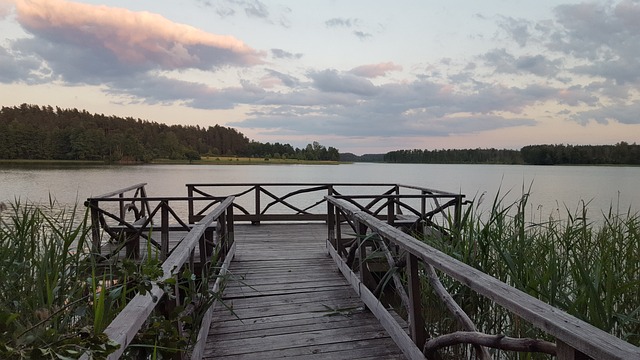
xmin=384 ymin=142 xmax=640 ymax=165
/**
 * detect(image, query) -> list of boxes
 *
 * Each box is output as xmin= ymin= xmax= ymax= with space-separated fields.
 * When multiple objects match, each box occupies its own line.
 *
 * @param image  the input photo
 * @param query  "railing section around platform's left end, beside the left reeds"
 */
xmin=85 ymin=184 xmax=226 ymax=259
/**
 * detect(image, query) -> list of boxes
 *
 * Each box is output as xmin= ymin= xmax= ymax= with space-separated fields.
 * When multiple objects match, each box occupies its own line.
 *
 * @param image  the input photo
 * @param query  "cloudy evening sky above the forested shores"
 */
xmin=0 ymin=0 xmax=640 ymax=154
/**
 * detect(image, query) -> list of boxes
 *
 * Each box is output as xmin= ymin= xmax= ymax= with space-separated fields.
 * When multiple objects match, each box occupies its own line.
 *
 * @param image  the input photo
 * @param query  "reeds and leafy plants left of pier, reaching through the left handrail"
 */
xmin=0 ymin=200 xmax=217 ymax=359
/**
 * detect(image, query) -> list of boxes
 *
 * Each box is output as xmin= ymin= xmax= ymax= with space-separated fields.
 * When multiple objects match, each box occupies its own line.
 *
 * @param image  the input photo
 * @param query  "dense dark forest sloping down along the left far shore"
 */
xmin=0 ymin=104 xmax=339 ymax=163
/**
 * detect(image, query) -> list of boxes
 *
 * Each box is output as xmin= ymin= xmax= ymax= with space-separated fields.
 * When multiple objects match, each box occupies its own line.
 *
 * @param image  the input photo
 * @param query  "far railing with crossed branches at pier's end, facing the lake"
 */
xmin=187 ymin=183 xmax=464 ymax=224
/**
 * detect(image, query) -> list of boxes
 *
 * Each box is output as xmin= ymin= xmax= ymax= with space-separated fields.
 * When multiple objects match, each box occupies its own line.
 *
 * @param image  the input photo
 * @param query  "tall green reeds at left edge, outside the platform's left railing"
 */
xmin=0 ymin=201 xmax=119 ymax=359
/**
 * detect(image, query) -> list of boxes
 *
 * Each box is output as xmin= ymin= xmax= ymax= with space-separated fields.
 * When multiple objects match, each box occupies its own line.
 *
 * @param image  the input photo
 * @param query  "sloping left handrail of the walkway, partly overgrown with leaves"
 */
xmin=83 ymin=196 xmax=235 ymax=359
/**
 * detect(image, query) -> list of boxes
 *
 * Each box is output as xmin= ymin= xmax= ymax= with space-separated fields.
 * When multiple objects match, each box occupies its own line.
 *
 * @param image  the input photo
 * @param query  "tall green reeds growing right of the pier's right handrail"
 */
xmin=423 ymin=189 xmax=640 ymax=358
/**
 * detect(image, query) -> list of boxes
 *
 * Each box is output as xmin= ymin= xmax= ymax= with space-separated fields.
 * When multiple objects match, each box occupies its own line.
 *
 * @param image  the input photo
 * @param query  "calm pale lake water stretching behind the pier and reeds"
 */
xmin=0 ymin=163 xmax=640 ymax=217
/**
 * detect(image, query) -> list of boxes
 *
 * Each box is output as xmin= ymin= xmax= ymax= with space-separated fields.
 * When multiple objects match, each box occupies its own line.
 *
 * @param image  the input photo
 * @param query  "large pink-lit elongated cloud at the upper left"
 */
xmin=16 ymin=0 xmax=264 ymax=69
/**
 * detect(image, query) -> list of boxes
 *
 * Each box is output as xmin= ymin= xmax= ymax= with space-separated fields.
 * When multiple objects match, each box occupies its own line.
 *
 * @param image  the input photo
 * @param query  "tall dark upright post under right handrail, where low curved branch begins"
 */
xmin=407 ymin=254 xmax=426 ymax=349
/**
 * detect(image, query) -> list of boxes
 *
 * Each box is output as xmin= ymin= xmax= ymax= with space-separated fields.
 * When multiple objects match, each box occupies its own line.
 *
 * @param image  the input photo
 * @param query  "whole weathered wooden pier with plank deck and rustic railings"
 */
xmin=82 ymin=183 xmax=640 ymax=360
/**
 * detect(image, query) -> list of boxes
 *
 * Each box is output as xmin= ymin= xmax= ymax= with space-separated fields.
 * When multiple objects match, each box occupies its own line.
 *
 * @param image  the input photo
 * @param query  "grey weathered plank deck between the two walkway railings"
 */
xmin=203 ymin=224 xmax=405 ymax=359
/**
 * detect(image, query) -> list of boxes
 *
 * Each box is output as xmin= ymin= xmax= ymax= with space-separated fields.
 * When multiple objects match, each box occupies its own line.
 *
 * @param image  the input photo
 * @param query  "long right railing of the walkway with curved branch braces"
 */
xmin=327 ymin=196 xmax=640 ymax=360
